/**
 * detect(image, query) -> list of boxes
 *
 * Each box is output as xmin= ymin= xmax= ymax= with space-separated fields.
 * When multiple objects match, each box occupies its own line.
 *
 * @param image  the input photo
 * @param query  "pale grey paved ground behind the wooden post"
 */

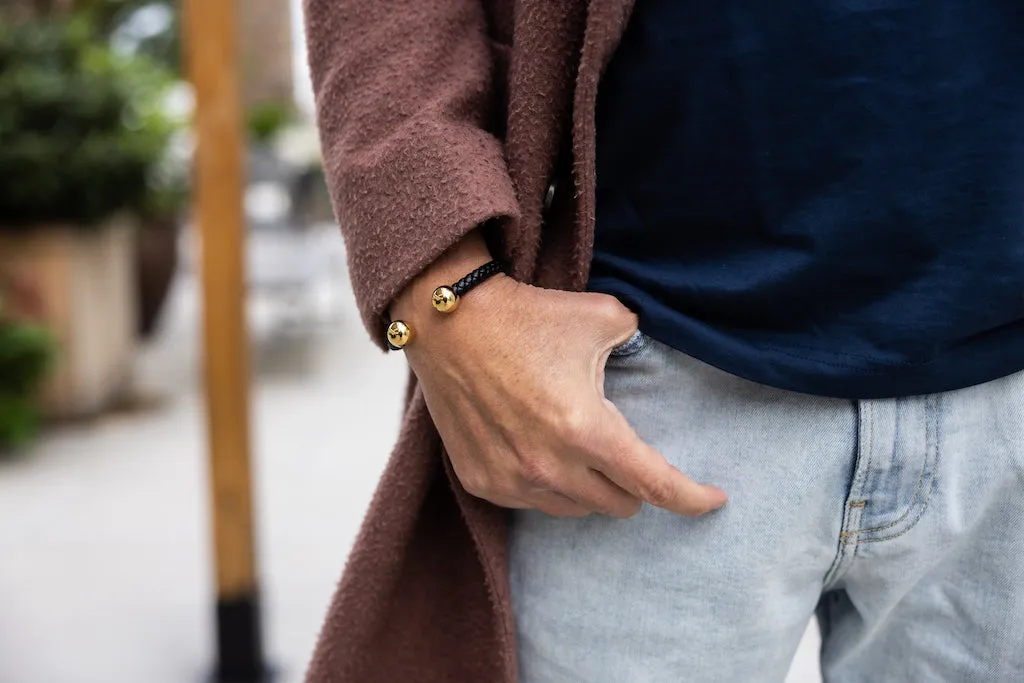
xmin=0 ymin=232 xmax=818 ymax=683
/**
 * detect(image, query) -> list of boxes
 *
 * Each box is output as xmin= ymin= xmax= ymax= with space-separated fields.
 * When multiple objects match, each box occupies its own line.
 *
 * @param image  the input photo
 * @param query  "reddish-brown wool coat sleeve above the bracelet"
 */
xmin=305 ymin=0 xmax=517 ymax=345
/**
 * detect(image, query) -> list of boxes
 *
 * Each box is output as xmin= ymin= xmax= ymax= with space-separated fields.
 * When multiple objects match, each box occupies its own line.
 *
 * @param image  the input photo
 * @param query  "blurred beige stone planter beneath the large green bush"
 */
xmin=0 ymin=218 xmax=136 ymax=419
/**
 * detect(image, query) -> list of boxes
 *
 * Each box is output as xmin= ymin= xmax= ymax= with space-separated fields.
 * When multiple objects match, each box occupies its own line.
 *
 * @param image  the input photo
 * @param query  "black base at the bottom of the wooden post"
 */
xmin=214 ymin=592 xmax=271 ymax=683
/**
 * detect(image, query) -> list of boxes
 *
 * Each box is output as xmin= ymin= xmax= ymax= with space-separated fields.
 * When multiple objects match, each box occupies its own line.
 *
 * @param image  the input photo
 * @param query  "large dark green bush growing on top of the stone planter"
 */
xmin=0 ymin=12 xmax=172 ymax=229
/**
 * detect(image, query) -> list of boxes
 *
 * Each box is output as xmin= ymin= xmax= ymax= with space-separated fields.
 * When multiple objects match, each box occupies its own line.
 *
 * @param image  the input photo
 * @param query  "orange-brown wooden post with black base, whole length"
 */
xmin=183 ymin=0 xmax=266 ymax=683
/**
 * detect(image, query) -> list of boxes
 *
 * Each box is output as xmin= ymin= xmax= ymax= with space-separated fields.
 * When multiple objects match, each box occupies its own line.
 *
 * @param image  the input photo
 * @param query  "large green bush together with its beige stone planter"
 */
xmin=0 ymin=12 xmax=165 ymax=416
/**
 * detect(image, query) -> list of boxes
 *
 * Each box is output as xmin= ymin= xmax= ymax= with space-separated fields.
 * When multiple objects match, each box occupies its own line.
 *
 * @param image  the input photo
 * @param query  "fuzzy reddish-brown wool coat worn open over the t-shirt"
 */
xmin=305 ymin=0 xmax=633 ymax=683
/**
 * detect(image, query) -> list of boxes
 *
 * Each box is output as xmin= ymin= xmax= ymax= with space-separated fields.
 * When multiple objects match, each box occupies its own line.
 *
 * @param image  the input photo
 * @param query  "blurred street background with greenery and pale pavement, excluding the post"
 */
xmin=0 ymin=0 xmax=818 ymax=683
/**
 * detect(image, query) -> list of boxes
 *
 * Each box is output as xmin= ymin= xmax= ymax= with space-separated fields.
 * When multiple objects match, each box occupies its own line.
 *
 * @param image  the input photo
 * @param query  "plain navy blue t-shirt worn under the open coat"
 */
xmin=590 ymin=0 xmax=1024 ymax=398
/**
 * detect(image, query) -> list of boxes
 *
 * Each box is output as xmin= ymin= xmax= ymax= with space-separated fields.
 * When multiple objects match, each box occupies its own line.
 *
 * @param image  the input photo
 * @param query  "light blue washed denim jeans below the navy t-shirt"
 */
xmin=510 ymin=335 xmax=1024 ymax=683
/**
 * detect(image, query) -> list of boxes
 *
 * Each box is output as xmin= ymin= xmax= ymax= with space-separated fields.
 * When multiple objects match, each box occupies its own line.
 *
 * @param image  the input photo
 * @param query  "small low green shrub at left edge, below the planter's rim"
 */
xmin=0 ymin=299 xmax=54 ymax=452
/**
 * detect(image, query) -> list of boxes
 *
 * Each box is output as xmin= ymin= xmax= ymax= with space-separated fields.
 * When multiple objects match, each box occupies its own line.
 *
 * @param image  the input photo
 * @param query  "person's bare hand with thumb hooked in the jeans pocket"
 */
xmin=391 ymin=234 xmax=726 ymax=517
